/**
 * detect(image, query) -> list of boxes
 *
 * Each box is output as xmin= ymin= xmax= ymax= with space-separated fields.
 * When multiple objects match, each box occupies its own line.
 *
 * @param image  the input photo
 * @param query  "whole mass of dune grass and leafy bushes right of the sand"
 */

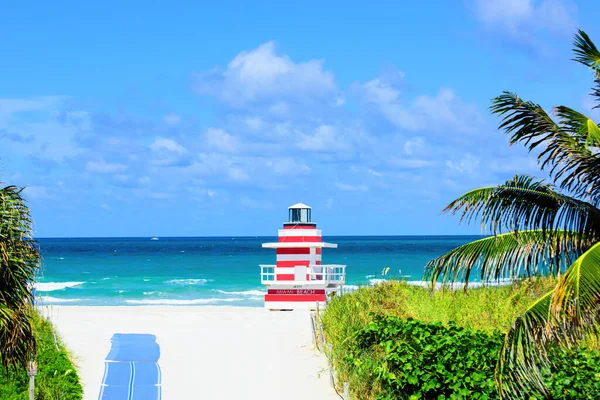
xmin=321 ymin=277 xmax=600 ymax=400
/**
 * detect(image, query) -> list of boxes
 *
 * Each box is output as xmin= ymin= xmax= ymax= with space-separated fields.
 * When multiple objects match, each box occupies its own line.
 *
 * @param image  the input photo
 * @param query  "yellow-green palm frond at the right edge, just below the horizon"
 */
xmin=551 ymin=242 xmax=600 ymax=342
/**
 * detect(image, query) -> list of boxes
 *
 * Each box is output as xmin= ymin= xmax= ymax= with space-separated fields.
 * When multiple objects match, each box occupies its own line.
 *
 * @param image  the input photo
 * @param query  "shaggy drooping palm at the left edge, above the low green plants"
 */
xmin=0 ymin=186 xmax=40 ymax=370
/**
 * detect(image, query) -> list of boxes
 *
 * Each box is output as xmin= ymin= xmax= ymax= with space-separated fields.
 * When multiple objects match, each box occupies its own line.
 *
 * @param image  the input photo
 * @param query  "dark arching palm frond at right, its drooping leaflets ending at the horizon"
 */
xmin=443 ymin=175 xmax=600 ymax=237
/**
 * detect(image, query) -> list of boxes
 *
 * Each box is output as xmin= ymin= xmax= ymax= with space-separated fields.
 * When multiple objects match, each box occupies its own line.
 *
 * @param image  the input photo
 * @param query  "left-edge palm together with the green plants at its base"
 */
xmin=0 ymin=186 xmax=82 ymax=400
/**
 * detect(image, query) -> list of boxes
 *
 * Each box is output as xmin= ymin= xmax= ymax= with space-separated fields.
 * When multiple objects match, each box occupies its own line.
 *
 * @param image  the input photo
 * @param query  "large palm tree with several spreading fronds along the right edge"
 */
xmin=426 ymin=31 xmax=600 ymax=398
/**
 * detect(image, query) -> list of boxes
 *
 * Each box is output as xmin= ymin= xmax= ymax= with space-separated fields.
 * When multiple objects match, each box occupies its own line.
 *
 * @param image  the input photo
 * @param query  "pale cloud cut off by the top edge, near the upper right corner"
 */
xmin=474 ymin=0 xmax=577 ymax=40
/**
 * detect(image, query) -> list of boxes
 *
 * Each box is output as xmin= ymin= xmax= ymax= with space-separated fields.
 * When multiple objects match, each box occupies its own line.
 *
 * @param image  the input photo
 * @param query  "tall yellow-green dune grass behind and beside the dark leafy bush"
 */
xmin=321 ymin=277 xmax=556 ymax=399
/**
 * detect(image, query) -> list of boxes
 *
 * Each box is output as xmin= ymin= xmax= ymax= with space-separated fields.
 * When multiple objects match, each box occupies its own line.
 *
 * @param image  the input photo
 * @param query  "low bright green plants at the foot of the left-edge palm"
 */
xmin=0 ymin=313 xmax=83 ymax=400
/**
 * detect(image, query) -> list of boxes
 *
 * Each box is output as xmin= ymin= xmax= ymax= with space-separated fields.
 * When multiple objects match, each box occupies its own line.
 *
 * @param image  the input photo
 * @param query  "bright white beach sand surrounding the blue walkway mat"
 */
xmin=42 ymin=306 xmax=339 ymax=400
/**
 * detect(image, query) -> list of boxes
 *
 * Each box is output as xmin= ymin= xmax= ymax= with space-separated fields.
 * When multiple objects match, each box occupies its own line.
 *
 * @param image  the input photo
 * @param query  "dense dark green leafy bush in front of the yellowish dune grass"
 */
xmin=346 ymin=316 xmax=503 ymax=400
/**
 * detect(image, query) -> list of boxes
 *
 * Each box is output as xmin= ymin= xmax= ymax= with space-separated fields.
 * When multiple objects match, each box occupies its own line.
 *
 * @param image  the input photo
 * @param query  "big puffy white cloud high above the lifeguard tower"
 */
xmin=194 ymin=41 xmax=337 ymax=106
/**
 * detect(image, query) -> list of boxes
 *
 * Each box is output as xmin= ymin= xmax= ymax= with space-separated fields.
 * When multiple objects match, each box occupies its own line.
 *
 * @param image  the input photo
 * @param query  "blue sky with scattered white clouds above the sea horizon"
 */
xmin=0 ymin=0 xmax=600 ymax=237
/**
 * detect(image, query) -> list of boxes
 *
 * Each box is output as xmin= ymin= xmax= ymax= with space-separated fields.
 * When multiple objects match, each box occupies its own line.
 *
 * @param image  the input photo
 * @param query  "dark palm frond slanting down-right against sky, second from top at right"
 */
xmin=490 ymin=92 xmax=600 ymax=204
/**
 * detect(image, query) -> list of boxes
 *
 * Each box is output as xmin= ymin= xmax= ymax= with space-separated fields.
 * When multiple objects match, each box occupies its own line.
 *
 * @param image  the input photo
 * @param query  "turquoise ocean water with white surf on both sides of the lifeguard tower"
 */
xmin=36 ymin=236 xmax=479 ymax=306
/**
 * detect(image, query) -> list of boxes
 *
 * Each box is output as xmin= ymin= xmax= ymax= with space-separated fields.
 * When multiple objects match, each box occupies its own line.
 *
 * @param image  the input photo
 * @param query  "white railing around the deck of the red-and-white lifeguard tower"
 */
xmin=260 ymin=264 xmax=346 ymax=285
